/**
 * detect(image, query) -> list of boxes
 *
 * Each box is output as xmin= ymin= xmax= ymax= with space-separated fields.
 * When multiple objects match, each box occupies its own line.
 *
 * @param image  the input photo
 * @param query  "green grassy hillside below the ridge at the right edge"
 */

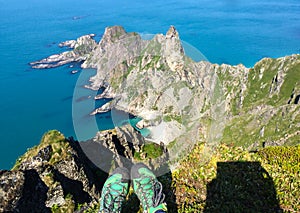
xmin=220 ymin=55 xmax=300 ymax=147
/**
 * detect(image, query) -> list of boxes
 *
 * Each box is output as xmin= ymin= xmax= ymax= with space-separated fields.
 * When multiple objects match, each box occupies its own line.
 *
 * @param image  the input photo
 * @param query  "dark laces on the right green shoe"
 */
xmin=137 ymin=176 xmax=165 ymax=208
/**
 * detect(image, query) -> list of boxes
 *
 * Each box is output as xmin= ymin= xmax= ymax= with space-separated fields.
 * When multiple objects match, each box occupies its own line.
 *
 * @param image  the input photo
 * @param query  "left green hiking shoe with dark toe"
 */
xmin=99 ymin=167 xmax=129 ymax=213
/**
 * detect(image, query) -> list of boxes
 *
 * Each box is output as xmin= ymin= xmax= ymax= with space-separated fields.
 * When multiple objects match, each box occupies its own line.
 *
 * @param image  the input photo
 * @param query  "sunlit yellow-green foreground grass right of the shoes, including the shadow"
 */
xmin=172 ymin=144 xmax=300 ymax=213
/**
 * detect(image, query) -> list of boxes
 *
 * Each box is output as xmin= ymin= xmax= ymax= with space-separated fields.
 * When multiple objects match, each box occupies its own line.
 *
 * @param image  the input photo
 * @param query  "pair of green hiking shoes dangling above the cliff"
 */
xmin=100 ymin=163 xmax=167 ymax=213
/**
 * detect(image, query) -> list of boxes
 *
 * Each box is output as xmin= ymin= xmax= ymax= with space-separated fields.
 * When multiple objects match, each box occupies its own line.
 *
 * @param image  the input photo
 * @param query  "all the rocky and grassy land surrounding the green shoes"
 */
xmin=0 ymin=26 xmax=300 ymax=212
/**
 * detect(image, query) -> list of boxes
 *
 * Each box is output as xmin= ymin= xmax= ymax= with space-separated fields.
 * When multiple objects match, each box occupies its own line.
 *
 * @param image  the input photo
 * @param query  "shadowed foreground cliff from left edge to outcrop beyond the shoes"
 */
xmin=0 ymin=125 xmax=166 ymax=212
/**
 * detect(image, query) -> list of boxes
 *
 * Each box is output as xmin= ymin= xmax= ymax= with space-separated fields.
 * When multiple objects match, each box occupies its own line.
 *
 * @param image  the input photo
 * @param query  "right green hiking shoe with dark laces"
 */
xmin=131 ymin=163 xmax=167 ymax=213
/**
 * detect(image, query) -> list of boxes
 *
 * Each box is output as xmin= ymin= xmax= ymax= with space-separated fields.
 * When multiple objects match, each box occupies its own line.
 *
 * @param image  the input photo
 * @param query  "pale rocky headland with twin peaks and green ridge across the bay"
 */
xmin=29 ymin=26 xmax=300 ymax=153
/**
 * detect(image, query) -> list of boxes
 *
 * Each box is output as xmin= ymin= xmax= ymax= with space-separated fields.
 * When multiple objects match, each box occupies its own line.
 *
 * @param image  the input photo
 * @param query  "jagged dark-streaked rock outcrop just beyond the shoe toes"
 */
xmin=89 ymin=124 xmax=169 ymax=175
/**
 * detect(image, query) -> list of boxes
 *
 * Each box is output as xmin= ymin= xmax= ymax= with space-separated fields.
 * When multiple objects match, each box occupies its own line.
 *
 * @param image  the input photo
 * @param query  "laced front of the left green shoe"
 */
xmin=103 ymin=183 xmax=126 ymax=213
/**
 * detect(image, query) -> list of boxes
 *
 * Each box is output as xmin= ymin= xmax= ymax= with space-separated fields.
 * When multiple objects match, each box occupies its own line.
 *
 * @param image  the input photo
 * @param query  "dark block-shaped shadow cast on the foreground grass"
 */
xmin=204 ymin=162 xmax=282 ymax=213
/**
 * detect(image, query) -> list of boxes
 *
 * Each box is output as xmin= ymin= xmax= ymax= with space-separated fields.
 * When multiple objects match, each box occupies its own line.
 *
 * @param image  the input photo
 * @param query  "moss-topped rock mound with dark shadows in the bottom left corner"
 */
xmin=0 ymin=131 xmax=105 ymax=212
